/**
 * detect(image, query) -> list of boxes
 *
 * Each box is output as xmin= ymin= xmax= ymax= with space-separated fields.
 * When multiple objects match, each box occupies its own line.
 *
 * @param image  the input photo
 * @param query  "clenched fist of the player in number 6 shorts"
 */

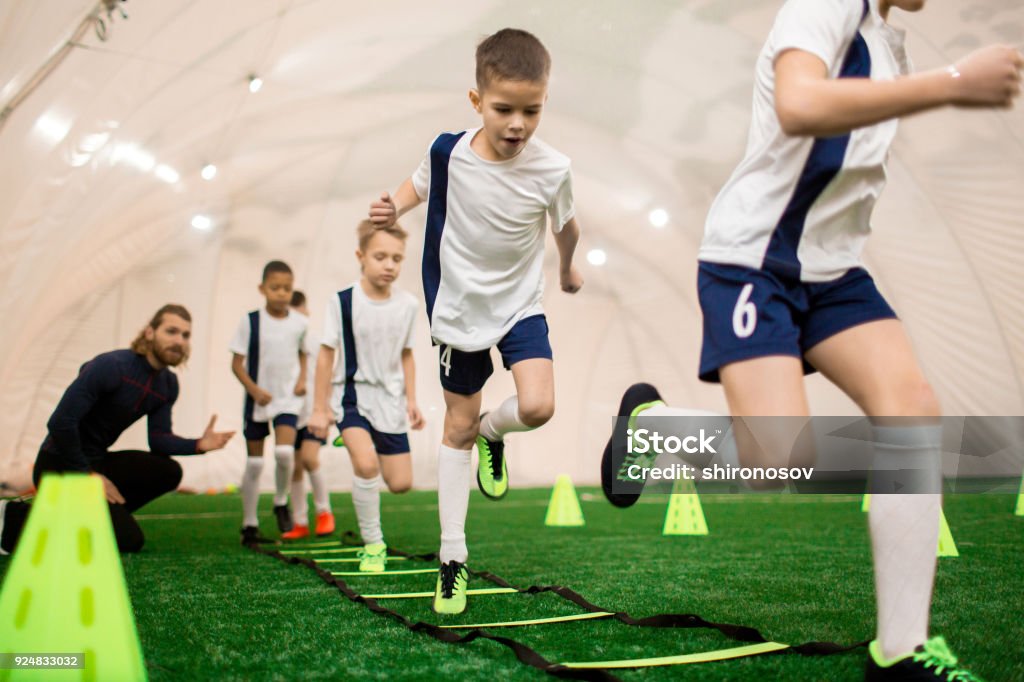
xmin=950 ymin=45 xmax=1024 ymax=108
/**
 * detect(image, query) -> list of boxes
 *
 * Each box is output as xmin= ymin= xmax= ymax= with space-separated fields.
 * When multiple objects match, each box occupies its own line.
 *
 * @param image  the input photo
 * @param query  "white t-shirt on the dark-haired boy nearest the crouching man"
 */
xmin=230 ymin=308 xmax=309 ymax=422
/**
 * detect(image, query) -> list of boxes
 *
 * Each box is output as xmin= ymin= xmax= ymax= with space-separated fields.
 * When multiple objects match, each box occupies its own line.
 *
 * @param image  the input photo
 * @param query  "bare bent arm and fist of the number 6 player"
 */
xmin=775 ymin=45 xmax=1022 ymax=137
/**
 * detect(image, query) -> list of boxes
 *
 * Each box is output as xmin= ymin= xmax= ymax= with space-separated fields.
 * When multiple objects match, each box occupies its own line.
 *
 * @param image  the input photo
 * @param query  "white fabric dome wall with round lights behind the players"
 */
xmin=0 ymin=0 xmax=1024 ymax=489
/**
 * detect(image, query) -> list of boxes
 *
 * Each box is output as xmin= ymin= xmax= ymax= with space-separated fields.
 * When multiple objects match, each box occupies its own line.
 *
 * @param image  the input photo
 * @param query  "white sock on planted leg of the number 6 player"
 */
xmin=868 ymin=426 xmax=942 ymax=659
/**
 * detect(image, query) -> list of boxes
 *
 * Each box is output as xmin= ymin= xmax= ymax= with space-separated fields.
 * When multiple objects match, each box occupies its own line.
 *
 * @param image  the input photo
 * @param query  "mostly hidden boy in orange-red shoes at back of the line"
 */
xmin=281 ymin=289 xmax=334 ymax=540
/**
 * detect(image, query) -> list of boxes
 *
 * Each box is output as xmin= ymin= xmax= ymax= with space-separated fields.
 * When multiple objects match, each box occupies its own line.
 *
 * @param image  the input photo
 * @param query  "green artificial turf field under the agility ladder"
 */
xmin=0 ymin=488 xmax=1024 ymax=680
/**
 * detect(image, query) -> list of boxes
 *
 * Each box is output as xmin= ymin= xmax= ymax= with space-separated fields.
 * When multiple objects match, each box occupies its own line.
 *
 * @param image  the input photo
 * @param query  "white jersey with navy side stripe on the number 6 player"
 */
xmin=698 ymin=0 xmax=910 ymax=282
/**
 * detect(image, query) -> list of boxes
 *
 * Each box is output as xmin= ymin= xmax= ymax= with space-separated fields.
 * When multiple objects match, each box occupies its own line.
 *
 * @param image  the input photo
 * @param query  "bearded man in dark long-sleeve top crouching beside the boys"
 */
xmin=0 ymin=304 xmax=233 ymax=553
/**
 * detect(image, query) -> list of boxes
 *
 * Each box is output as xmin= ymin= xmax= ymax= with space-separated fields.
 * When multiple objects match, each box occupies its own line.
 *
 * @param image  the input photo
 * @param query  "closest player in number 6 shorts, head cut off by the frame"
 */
xmin=602 ymin=0 xmax=1022 ymax=680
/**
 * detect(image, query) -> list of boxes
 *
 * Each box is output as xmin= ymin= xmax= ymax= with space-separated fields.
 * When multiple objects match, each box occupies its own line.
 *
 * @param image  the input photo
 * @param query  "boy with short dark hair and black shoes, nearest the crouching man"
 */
xmin=230 ymin=260 xmax=308 ymax=545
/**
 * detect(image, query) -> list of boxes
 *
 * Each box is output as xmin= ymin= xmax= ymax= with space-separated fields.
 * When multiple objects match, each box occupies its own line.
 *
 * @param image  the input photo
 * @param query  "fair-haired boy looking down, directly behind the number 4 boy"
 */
xmin=309 ymin=220 xmax=424 ymax=572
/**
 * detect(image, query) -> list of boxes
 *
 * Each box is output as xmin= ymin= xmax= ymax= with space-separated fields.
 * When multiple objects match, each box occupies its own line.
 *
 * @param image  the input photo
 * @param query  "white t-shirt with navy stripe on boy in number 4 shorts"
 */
xmin=413 ymin=128 xmax=574 ymax=351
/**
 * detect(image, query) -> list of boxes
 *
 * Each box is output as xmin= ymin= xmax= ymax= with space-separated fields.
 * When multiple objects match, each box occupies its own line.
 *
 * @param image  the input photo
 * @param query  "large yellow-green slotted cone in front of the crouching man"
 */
xmin=0 ymin=474 xmax=146 ymax=681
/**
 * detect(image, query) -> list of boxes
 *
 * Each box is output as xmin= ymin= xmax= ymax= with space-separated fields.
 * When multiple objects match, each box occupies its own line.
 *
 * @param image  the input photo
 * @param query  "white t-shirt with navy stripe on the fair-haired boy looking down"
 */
xmin=321 ymin=282 xmax=419 ymax=433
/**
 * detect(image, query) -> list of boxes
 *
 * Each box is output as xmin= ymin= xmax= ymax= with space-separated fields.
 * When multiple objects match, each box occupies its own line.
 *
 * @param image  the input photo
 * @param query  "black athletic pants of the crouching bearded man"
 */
xmin=32 ymin=450 xmax=181 ymax=552
